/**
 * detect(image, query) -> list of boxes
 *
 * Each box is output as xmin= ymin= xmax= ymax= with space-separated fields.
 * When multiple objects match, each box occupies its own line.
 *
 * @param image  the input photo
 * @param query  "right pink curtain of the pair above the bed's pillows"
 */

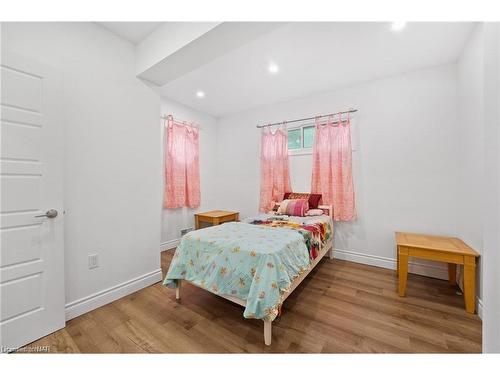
xmin=311 ymin=115 xmax=356 ymax=221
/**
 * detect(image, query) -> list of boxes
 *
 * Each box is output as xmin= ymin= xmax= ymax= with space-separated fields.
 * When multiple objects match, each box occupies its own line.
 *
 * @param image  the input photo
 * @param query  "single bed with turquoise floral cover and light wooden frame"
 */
xmin=164 ymin=206 xmax=333 ymax=345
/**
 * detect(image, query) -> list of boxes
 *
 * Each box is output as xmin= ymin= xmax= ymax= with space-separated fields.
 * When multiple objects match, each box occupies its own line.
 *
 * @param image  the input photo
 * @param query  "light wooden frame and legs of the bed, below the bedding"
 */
xmin=175 ymin=205 xmax=333 ymax=345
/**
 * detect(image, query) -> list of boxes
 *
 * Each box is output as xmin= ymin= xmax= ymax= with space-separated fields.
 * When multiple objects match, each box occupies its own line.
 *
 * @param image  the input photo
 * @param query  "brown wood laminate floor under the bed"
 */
xmin=29 ymin=251 xmax=481 ymax=353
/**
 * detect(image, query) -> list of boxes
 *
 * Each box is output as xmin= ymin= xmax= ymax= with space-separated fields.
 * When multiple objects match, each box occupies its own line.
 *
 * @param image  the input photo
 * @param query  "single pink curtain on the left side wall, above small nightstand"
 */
xmin=163 ymin=116 xmax=200 ymax=208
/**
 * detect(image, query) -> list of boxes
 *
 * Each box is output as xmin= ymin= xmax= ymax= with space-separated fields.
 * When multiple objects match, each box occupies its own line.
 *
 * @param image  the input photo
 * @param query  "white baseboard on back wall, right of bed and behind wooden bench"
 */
xmin=333 ymin=249 xmax=448 ymax=280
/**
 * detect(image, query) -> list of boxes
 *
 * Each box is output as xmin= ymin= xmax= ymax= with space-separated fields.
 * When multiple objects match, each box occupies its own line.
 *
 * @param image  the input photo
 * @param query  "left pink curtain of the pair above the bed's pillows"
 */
xmin=259 ymin=128 xmax=291 ymax=212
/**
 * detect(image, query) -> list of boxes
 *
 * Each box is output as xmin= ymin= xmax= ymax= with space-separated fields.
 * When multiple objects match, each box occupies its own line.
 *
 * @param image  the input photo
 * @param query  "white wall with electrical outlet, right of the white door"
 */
xmin=2 ymin=23 xmax=161 ymax=314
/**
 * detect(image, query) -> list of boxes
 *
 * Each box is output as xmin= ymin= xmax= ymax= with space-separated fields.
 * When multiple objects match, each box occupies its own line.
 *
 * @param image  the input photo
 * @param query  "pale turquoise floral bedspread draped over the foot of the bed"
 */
xmin=163 ymin=217 xmax=331 ymax=320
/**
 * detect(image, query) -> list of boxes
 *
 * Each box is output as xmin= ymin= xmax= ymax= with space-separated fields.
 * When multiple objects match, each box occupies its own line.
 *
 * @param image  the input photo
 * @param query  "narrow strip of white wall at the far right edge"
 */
xmin=483 ymin=23 xmax=500 ymax=353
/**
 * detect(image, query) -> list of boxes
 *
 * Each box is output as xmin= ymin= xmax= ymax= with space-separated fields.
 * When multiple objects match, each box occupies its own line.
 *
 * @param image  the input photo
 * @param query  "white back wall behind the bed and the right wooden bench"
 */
xmin=217 ymin=64 xmax=462 ymax=276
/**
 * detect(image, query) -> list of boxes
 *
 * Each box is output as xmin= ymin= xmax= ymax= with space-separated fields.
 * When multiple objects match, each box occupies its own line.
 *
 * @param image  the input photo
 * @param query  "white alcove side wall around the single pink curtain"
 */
xmin=160 ymin=98 xmax=218 ymax=249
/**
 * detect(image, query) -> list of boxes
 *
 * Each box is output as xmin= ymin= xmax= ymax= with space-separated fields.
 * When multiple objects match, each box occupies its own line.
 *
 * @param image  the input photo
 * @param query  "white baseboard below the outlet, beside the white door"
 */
xmin=66 ymin=269 xmax=162 ymax=321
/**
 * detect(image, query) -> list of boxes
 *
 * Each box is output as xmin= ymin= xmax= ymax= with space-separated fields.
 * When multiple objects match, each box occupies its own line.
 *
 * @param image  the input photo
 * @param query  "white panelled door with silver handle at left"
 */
xmin=0 ymin=52 xmax=65 ymax=352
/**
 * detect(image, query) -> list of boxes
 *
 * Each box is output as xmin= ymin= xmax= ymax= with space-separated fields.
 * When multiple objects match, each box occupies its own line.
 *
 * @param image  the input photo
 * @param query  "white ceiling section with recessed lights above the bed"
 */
xmin=160 ymin=22 xmax=474 ymax=116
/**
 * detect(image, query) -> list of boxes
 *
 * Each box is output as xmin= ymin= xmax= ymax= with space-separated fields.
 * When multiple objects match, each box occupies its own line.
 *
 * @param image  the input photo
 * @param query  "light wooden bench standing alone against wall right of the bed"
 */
xmin=396 ymin=232 xmax=479 ymax=314
